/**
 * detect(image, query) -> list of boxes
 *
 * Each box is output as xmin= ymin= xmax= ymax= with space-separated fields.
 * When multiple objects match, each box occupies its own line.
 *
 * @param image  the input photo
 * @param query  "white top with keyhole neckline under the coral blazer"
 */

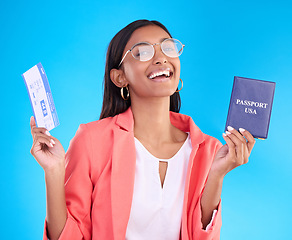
xmin=126 ymin=135 xmax=192 ymax=240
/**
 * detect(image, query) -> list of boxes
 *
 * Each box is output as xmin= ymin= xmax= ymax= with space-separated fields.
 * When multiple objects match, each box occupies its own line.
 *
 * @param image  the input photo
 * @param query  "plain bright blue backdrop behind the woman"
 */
xmin=0 ymin=0 xmax=292 ymax=240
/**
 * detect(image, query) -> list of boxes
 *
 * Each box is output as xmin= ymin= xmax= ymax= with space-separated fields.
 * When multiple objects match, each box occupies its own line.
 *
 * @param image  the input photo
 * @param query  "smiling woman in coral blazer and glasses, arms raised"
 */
xmin=31 ymin=20 xmax=255 ymax=240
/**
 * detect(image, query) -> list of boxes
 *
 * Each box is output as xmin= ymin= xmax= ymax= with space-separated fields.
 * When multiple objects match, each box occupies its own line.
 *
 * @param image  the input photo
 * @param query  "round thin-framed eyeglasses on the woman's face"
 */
xmin=118 ymin=38 xmax=185 ymax=67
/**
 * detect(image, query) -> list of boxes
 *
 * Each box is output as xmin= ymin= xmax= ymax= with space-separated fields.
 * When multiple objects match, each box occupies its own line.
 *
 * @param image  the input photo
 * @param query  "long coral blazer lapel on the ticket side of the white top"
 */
xmin=111 ymin=108 xmax=136 ymax=239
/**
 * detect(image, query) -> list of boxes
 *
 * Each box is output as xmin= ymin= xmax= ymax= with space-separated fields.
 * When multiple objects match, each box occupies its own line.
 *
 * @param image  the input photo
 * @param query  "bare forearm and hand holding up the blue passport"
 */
xmin=201 ymin=127 xmax=255 ymax=229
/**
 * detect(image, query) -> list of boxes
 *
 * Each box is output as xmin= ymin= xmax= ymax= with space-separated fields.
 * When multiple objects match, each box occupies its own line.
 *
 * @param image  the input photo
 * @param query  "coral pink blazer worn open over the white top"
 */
xmin=44 ymin=108 xmax=222 ymax=240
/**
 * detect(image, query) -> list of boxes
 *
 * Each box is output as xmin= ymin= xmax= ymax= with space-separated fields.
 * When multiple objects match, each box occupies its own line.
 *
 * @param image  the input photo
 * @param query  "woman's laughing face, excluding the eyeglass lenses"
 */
xmin=122 ymin=25 xmax=180 ymax=101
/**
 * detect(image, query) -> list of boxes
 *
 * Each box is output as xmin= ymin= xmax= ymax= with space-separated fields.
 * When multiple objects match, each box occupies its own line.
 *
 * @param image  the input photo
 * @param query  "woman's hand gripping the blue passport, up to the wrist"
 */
xmin=211 ymin=127 xmax=255 ymax=177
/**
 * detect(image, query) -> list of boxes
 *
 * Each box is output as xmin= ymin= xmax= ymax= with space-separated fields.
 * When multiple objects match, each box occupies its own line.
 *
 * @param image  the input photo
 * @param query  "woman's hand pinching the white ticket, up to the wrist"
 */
xmin=30 ymin=117 xmax=65 ymax=172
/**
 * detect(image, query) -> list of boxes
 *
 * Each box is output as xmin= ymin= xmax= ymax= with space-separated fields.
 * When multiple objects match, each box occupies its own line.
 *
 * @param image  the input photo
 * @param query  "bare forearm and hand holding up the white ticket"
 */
xmin=30 ymin=117 xmax=67 ymax=240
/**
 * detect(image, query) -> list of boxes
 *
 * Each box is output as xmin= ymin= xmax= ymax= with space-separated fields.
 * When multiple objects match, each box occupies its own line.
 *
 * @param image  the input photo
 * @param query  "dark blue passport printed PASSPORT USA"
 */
xmin=225 ymin=77 xmax=276 ymax=139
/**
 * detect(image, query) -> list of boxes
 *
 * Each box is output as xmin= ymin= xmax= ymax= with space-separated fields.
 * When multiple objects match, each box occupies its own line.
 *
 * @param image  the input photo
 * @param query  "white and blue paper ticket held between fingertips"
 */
xmin=22 ymin=63 xmax=59 ymax=131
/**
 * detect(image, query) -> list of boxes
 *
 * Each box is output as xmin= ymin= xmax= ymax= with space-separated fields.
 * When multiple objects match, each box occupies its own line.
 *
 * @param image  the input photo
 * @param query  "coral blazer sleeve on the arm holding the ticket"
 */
xmin=43 ymin=124 xmax=93 ymax=240
